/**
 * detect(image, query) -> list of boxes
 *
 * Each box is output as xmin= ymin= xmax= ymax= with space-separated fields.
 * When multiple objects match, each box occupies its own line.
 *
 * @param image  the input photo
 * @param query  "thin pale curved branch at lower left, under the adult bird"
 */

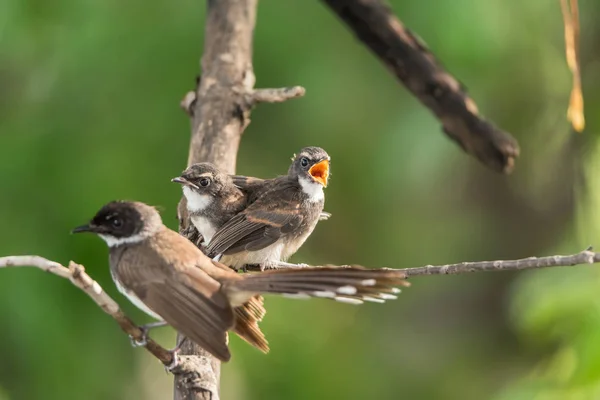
xmin=0 ymin=256 xmax=178 ymax=373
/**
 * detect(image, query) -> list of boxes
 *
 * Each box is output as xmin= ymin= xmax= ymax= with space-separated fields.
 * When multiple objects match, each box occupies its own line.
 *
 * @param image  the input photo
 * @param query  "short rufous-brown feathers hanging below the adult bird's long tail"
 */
xmin=233 ymin=296 xmax=269 ymax=353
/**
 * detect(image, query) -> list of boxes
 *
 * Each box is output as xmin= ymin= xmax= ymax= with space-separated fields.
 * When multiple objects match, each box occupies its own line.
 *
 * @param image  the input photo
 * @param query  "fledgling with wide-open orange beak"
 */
xmin=197 ymin=147 xmax=329 ymax=269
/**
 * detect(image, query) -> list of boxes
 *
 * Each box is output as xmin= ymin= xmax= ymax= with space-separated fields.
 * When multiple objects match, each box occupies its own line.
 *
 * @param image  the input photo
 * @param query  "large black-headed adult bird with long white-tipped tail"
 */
xmin=73 ymin=201 xmax=408 ymax=361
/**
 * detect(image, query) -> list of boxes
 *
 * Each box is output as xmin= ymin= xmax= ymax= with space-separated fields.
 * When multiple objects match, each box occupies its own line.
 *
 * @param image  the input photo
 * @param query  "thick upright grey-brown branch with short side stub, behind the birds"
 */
xmin=174 ymin=0 xmax=305 ymax=400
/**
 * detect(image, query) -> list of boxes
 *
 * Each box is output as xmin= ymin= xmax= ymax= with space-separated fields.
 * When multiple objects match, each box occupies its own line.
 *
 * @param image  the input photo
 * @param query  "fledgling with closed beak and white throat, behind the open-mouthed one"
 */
xmin=171 ymin=162 xmax=331 ymax=245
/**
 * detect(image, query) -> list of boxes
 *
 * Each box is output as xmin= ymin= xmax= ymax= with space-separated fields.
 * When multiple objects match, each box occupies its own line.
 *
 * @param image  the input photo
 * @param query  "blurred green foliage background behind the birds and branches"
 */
xmin=0 ymin=0 xmax=600 ymax=400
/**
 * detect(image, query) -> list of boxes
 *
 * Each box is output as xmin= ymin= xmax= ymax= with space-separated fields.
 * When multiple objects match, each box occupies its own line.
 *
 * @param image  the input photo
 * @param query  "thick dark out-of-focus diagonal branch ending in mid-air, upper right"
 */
xmin=323 ymin=0 xmax=519 ymax=173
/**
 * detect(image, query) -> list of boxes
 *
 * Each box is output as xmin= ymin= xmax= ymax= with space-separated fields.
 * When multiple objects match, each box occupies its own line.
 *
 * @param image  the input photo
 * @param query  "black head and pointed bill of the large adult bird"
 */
xmin=72 ymin=200 xmax=163 ymax=242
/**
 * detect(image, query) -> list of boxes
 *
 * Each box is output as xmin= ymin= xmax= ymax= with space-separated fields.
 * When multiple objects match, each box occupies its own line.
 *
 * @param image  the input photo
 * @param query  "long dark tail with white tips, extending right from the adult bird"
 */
xmin=225 ymin=267 xmax=409 ymax=304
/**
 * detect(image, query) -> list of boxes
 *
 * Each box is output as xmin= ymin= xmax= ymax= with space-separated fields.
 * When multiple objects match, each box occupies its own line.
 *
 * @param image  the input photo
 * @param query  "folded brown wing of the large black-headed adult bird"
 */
xmin=118 ymin=232 xmax=234 ymax=361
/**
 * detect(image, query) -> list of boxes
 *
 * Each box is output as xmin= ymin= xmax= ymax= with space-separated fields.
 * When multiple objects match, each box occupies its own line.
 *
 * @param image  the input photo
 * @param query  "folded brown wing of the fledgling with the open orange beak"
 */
xmin=207 ymin=184 xmax=304 ymax=257
